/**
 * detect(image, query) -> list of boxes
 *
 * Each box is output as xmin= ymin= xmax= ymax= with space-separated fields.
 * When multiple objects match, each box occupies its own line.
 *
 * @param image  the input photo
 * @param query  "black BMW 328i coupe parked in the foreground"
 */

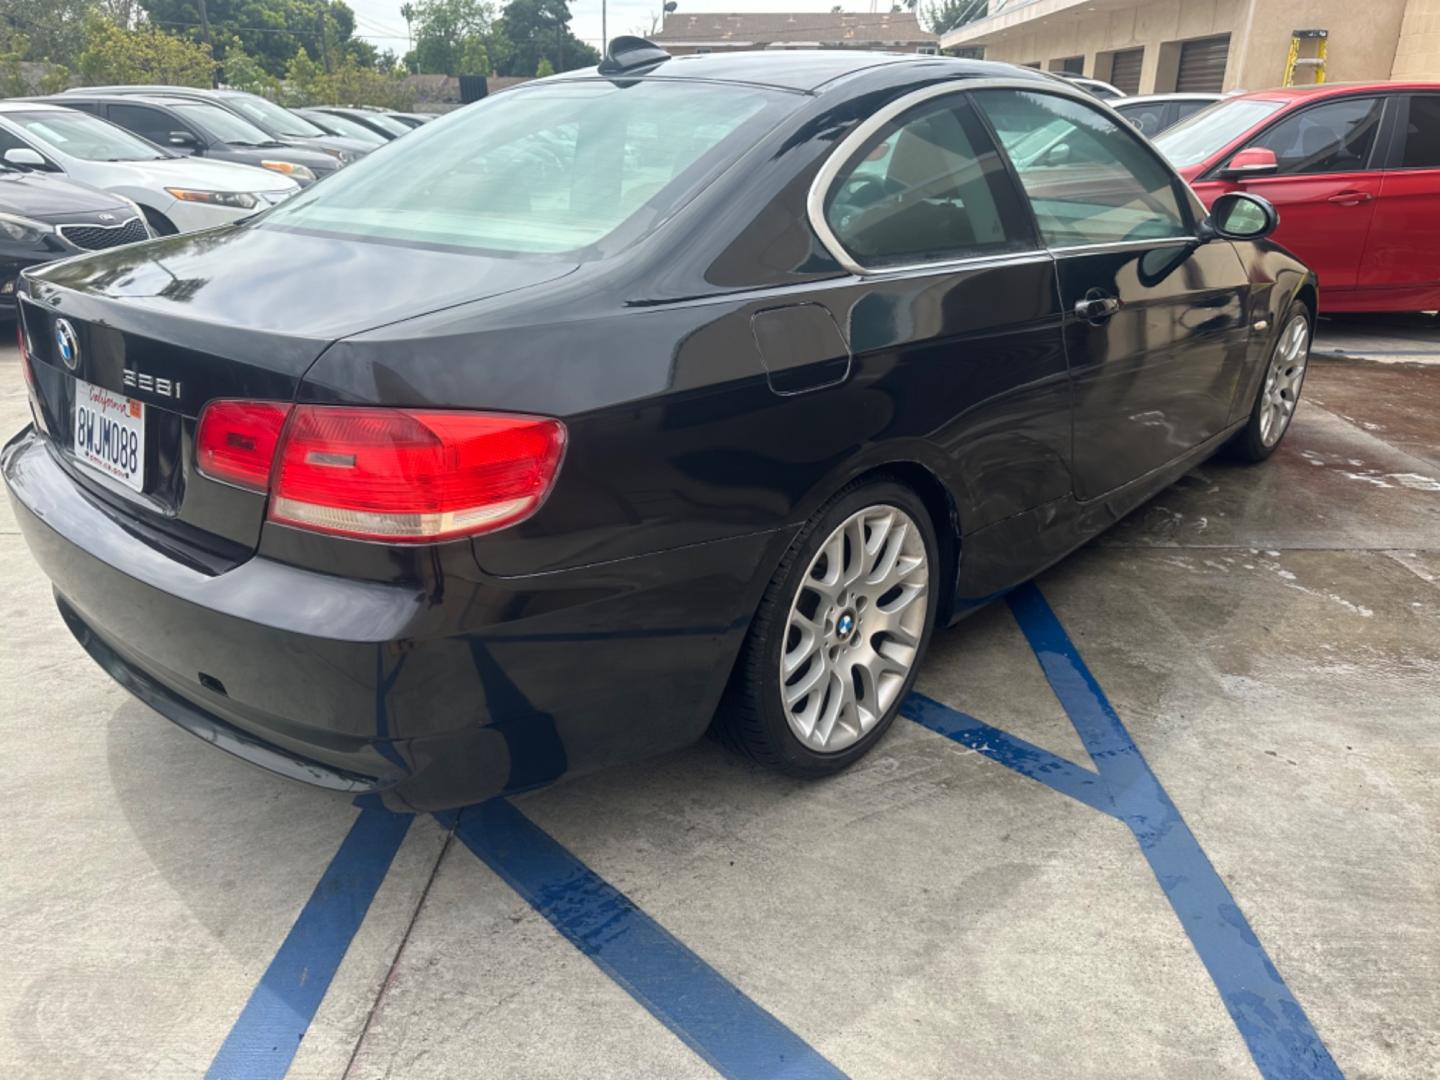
xmin=0 ymin=52 xmax=1316 ymax=808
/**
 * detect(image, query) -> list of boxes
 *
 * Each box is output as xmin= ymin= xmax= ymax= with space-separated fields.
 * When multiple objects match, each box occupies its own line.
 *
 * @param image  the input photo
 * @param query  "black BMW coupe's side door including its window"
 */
xmin=975 ymin=89 xmax=1248 ymax=500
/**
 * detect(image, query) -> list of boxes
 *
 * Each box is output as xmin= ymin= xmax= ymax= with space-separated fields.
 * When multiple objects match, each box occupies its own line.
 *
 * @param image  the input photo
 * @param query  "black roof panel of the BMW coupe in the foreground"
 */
xmin=556 ymin=49 xmax=1044 ymax=92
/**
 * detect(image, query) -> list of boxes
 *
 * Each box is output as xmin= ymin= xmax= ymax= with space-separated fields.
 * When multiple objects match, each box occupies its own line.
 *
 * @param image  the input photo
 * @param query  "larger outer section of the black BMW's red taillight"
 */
xmin=269 ymin=405 xmax=564 ymax=543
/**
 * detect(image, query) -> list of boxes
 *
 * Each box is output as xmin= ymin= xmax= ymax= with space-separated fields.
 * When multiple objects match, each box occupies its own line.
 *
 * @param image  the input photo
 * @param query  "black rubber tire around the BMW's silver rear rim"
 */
xmin=711 ymin=478 xmax=940 ymax=778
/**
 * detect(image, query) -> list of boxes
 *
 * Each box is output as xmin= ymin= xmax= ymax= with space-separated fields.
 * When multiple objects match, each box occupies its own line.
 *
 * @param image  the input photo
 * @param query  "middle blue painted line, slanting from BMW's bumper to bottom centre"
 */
xmin=436 ymin=799 xmax=844 ymax=1080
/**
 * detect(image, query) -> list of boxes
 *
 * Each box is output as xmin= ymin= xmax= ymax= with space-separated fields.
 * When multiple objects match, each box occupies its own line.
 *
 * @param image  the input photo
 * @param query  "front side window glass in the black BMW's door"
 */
xmin=975 ymin=91 xmax=1189 ymax=246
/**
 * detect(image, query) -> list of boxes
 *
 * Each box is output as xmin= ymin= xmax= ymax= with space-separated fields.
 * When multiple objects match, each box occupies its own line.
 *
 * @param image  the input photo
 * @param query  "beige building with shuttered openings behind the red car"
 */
xmin=940 ymin=0 xmax=1440 ymax=94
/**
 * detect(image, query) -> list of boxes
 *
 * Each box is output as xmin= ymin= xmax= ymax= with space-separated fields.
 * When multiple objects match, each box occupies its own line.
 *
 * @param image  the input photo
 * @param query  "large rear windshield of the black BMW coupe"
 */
xmin=259 ymin=79 xmax=804 ymax=258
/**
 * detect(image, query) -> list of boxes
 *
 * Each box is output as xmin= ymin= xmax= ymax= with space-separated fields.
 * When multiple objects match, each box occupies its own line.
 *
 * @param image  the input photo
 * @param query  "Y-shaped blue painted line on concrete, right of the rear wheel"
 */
xmin=906 ymin=583 xmax=1341 ymax=1080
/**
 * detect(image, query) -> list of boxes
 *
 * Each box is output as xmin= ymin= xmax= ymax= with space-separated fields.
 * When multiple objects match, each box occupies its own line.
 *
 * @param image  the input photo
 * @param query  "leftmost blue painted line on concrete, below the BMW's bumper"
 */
xmin=204 ymin=796 xmax=412 ymax=1080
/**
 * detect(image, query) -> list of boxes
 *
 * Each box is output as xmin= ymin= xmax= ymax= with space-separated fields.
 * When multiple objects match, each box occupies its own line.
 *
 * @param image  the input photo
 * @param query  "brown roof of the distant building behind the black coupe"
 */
xmin=651 ymin=12 xmax=939 ymax=48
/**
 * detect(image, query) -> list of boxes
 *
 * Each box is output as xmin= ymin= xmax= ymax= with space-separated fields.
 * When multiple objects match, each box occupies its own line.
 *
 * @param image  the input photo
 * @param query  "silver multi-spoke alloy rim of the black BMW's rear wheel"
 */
xmin=780 ymin=505 xmax=930 ymax=753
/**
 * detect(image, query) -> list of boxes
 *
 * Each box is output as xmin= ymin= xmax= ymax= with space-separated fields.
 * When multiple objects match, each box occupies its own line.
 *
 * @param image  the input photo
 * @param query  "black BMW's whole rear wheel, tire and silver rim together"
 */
xmin=716 ymin=481 xmax=937 ymax=776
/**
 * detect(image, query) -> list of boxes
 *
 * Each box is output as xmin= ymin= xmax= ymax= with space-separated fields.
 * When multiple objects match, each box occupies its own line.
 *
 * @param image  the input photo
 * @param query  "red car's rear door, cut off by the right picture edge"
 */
xmin=1353 ymin=94 xmax=1440 ymax=310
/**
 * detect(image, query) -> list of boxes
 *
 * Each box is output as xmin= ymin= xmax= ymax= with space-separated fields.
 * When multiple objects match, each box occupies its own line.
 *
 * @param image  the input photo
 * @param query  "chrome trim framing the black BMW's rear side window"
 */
xmin=805 ymin=79 xmax=1048 ymax=278
